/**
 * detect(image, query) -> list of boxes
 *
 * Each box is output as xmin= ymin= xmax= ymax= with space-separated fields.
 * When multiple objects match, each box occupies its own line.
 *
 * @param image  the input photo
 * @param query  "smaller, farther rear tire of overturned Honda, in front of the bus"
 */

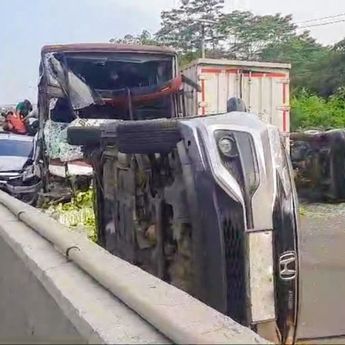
xmin=67 ymin=126 xmax=101 ymax=146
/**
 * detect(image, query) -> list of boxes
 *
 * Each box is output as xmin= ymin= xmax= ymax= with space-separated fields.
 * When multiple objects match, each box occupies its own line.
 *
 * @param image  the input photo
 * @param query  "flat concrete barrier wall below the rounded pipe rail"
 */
xmin=0 ymin=206 xmax=170 ymax=344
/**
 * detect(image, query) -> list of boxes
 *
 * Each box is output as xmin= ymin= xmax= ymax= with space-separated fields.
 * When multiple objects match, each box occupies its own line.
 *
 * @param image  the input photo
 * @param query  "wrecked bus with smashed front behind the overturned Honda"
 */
xmin=38 ymin=44 xmax=182 ymax=197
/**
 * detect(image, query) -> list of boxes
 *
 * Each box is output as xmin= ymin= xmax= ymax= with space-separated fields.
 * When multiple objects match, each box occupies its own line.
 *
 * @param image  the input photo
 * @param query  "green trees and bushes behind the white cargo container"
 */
xmin=110 ymin=0 xmax=345 ymax=130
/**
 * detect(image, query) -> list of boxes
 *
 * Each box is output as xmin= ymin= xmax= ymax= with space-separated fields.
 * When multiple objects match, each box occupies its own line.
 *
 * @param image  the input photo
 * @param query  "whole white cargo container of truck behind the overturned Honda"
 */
xmin=182 ymin=59 xmax=291 ymax=134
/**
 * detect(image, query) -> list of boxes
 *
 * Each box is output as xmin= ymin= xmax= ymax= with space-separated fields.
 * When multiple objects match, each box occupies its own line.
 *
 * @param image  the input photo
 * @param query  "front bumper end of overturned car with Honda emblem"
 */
xmin=178 ymin=113 xmax=298 ymax=337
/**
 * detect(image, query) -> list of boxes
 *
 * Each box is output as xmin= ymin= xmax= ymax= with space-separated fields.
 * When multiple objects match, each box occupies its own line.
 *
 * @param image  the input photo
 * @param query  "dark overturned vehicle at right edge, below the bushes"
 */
xmin=290 ymin=129 xmax=345 ymax=202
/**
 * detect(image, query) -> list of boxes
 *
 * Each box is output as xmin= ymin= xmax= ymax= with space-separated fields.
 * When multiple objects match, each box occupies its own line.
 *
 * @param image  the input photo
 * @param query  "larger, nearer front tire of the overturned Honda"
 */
xmin=117 ymin=119 xmax=181 ymax=154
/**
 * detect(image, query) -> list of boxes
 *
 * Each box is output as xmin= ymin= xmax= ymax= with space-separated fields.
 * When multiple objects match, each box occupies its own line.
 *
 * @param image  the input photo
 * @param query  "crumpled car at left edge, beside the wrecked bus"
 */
xmin=0 ymin=132 xmax=41 ymax=204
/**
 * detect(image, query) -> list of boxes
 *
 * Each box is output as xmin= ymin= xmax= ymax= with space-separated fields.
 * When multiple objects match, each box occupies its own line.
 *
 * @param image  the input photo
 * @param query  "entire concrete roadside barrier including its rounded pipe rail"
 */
xmin=0 ymin=192 xmax=267 ymax=344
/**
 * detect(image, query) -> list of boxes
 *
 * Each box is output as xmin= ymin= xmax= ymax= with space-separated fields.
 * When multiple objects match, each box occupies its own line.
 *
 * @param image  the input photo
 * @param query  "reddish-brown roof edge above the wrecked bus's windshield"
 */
xmin=41 ymin=43 xmax=176 ymax=55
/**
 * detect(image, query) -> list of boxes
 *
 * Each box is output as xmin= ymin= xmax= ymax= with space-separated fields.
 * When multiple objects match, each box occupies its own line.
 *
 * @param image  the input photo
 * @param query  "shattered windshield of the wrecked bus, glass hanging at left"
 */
xmin=45 ymin=53 xmax=177 ymax=122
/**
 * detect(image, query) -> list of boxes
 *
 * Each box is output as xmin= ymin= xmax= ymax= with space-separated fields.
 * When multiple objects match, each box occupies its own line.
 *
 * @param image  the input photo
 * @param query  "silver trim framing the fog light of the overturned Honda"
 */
xmin=184 ymin=113 xmax=278 ymax=231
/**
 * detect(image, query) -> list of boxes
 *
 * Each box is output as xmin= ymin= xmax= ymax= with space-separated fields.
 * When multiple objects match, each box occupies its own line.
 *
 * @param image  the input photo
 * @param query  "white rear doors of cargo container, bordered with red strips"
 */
xmin=197 ymin=66 xmax=290 ymax=133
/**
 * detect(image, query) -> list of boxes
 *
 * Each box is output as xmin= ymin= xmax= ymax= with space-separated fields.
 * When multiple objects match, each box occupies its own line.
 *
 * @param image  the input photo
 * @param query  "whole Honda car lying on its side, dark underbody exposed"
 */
xmin=68 ymin=112 xmax=299 ymax=343
